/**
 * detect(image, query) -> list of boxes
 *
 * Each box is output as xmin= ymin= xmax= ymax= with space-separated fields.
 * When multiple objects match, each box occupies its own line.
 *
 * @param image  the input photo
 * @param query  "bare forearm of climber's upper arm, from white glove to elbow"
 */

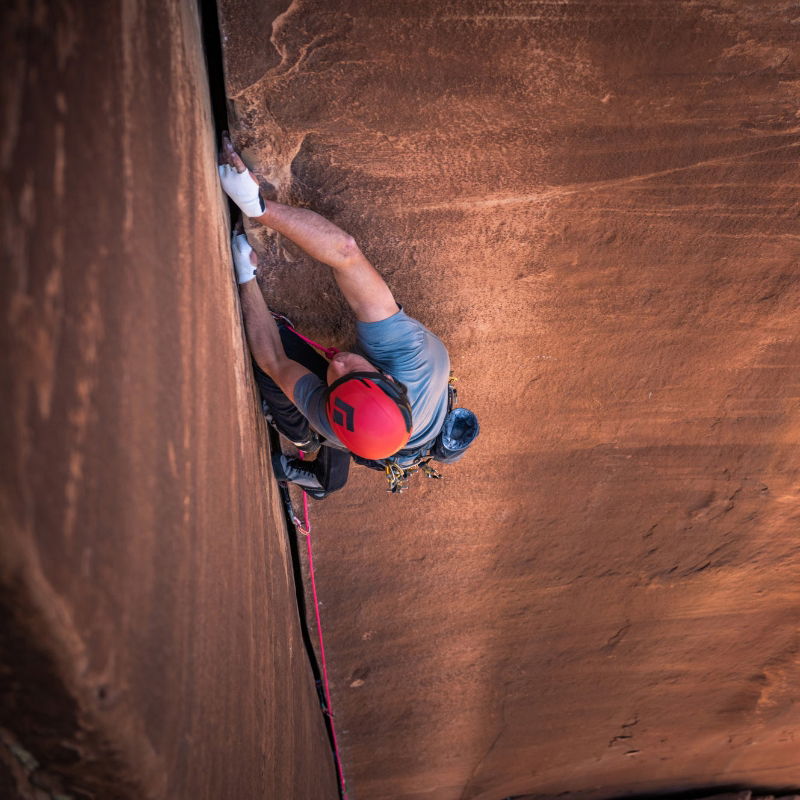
xmin=255 ymin=201 xmax=361 ymax=271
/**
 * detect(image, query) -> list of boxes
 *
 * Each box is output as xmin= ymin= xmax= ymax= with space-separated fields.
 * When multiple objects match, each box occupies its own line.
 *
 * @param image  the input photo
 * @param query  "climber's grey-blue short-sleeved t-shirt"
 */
xmin=294 ymin=309 xmax=450 ymax=450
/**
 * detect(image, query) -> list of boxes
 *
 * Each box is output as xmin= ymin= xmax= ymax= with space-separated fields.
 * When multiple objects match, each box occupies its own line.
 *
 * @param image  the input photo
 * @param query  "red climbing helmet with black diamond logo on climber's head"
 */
xmin=325 ymin=372 xmax=411 ymax=459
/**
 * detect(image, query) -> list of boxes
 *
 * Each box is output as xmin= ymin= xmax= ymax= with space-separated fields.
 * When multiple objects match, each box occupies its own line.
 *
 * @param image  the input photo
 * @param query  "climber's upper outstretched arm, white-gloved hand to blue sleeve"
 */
xmin=220 ymin=137 xmax=398 ymax=322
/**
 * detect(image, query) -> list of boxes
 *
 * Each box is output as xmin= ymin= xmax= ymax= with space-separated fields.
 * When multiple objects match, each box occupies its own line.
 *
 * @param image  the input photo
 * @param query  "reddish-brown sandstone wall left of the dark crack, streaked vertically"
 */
xmin=0 ymin=0 xmax=336 ymax=800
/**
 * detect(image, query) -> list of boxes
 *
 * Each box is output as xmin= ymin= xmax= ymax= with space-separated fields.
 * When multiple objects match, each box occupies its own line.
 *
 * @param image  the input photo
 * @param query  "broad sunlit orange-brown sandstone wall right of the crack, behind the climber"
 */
xmin=221 ymin=0 xmax=800 ymax=800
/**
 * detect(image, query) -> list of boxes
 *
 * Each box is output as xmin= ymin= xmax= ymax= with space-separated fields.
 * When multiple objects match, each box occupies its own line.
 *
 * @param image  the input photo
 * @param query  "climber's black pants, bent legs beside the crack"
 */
xmin=253 ymin=322 xmax=350 ymax=498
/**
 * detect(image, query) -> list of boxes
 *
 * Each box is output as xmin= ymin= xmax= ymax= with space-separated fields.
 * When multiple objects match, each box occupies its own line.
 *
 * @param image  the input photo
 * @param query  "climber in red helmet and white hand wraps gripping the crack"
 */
xmin=218 ymin=134 xmax=477 ymax=498
